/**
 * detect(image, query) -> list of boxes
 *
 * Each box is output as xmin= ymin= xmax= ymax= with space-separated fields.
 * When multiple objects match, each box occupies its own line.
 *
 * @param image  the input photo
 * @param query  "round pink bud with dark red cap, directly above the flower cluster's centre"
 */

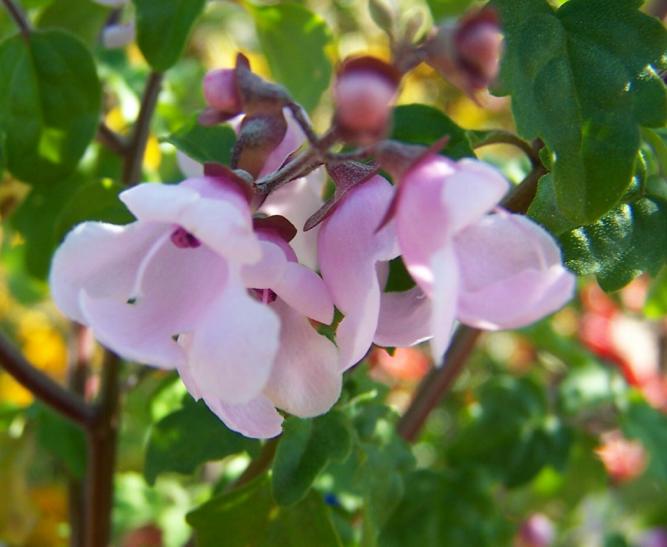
xmin=334 ymin=57 xmax=399 ymax=141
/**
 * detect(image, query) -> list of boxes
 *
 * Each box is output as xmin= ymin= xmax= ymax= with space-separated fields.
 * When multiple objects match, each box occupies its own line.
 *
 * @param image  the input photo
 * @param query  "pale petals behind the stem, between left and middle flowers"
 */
xmin=260 ymin=168 xmax=326 ymax=269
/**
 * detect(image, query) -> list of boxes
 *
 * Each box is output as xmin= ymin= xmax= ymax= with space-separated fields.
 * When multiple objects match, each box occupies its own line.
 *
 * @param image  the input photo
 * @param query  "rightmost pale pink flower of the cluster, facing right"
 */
xmin=395 ymin=156 xmax=574 ymax=360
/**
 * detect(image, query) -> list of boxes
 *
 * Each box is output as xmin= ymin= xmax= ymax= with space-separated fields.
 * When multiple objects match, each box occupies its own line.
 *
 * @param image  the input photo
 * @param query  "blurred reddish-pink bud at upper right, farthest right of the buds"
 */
xmin=426 ymin=8 xmax=503 ymax=94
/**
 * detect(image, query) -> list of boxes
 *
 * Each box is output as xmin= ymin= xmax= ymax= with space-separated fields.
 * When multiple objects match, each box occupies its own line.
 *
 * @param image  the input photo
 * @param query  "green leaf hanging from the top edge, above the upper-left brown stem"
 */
xmin=134 ymin=0 xmax=206 ymax=72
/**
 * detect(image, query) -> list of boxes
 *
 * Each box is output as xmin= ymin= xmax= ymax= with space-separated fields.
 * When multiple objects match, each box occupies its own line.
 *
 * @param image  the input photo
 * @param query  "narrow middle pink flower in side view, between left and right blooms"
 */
xmin=318 ymin=176 xmax=430 ymax=369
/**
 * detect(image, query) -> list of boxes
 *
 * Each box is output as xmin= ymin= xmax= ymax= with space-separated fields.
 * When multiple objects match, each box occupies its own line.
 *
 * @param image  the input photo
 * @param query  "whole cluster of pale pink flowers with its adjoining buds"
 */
xmin=50 ymin=49 xmax=574 ymax=438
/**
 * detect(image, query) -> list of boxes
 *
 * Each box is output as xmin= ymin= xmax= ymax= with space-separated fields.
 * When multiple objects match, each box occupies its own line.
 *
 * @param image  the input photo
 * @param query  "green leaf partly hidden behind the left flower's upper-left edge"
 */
xmin=56 ymin=179 xmax=134 ymax=241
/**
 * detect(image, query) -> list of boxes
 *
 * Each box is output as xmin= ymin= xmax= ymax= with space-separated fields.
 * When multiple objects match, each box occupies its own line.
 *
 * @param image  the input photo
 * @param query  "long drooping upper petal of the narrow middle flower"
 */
xmin=318 ymin=176 xmax=398 ymax=369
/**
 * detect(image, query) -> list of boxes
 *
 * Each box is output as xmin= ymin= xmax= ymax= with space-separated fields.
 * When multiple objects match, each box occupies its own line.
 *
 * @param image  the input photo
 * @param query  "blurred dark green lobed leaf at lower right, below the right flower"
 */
xmin=449 ymin=377 xmax=570 ymax=487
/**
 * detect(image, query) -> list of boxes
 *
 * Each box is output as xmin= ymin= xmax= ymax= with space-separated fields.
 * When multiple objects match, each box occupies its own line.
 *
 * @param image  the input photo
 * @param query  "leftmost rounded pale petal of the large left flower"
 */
xmin=49 ymin=222 xmax=164 ymax=323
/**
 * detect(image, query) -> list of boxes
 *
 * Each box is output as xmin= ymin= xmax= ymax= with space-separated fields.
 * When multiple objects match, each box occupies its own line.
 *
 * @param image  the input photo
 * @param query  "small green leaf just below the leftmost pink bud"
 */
xmin=164 ymin=120 xmax=236 ymax=165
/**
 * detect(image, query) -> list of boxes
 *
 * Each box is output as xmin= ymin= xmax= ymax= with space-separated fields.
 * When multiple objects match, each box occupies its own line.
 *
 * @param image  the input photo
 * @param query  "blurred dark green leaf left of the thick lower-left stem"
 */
xmin=32 ymin=403 xmax=86 ymax=479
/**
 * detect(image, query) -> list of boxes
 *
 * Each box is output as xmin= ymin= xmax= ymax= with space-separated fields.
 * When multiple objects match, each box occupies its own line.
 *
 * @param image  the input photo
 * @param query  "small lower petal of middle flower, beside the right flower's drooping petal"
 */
xmin=373 ymin=287 xmax=432 ymax=347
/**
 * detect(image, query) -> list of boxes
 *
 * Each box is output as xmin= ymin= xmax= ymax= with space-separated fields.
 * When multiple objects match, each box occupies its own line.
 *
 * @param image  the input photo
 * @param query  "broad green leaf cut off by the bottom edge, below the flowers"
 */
xmin=187 ymin=476 xmax=341 ymax=547
